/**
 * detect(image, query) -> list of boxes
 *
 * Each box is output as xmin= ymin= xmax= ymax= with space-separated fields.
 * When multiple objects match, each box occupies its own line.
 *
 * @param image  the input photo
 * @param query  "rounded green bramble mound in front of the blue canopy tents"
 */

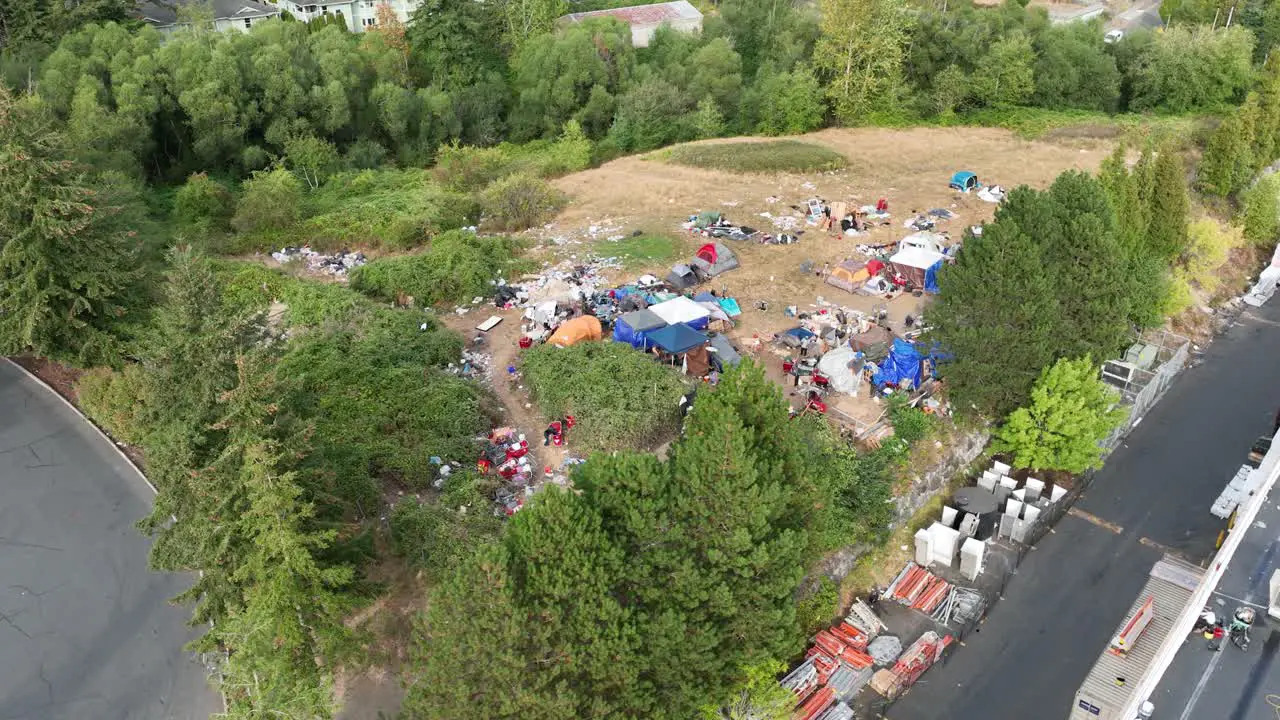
xmin=524 ymin=342 xmax=685 ymax=450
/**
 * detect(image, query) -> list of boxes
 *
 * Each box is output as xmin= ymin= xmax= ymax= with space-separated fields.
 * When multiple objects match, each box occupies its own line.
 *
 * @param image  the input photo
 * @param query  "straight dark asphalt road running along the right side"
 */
xmin=887 ymin=301 xmax=1280 ymax=720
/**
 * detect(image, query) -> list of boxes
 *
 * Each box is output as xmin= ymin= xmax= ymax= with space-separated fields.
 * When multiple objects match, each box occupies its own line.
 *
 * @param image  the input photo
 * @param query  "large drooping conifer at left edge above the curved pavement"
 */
xmin=0 ymin=87 xmax=141 ymax=364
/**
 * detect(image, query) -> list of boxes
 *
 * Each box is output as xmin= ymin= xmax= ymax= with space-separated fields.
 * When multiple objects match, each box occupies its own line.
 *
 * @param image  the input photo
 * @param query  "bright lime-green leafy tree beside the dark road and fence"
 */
xmin=992 ymin=356 xmax=1126 ymax=473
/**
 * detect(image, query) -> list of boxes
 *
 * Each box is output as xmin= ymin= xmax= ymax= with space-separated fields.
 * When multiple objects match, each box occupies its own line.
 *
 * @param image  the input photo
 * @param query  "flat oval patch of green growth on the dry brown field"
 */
xmin=663 ymin=140 xmax=847 ymax=173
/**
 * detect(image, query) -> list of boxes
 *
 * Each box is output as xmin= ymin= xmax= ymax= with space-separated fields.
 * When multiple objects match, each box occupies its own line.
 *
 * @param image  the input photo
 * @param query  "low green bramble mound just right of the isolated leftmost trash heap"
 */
xmin=351 ymin=231 xmax=516 ymax=306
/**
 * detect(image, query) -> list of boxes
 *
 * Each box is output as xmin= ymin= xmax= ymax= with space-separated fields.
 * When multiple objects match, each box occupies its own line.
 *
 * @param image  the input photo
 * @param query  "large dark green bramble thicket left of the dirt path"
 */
xmin=278 ymin=307 xmax=489 ymax=502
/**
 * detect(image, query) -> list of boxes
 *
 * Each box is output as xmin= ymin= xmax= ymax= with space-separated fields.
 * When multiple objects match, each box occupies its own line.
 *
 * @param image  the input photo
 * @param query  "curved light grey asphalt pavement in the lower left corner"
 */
xmin=0 ymin=361 xmax=221 ymax=720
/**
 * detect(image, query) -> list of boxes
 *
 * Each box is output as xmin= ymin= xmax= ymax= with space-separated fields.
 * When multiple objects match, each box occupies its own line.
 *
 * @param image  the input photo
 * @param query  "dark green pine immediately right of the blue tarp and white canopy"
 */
xmin=929 ymin=187 xmax=1064 ymax=415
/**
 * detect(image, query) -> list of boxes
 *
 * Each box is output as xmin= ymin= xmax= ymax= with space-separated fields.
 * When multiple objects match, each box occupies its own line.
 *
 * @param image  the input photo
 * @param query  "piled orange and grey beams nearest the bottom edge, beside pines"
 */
xmin=781 ymin=601 xmax=901 ymax=720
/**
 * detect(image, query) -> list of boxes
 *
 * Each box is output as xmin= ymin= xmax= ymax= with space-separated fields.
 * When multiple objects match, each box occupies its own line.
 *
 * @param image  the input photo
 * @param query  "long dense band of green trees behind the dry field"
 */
xmin=5 ymin=0 xmax=1275 ymax=181
